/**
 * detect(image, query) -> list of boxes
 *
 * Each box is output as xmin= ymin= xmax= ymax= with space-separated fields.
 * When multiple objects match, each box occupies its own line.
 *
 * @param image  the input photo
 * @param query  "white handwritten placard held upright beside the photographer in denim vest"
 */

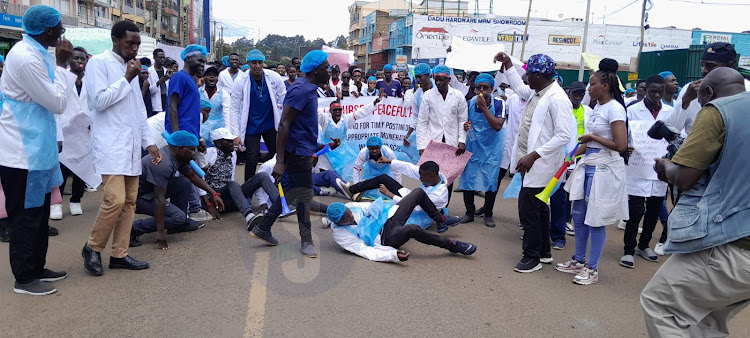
xmin=625 ymin=120 xmax=669 ymax=180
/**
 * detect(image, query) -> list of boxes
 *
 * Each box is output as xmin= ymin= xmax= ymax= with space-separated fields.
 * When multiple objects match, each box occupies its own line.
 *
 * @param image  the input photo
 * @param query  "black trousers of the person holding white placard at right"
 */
xmin=623 ymin=195 xmax=664 ymax=255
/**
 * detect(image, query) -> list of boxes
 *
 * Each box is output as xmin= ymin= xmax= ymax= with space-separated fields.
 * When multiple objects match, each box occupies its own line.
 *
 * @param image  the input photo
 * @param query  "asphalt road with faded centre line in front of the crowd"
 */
xmin=0 ymin=172 xmax=750 ymax=337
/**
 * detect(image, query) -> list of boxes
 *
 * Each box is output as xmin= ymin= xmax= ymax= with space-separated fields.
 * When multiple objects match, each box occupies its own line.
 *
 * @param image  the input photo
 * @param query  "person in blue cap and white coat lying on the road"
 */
xmin=326 ymin=188 xmax=477 ymax=262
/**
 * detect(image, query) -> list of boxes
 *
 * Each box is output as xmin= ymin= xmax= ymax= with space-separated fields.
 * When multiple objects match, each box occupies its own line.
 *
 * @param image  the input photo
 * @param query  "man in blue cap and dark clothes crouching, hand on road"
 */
xmin=130 ymin=130 xmax=224 ymax=250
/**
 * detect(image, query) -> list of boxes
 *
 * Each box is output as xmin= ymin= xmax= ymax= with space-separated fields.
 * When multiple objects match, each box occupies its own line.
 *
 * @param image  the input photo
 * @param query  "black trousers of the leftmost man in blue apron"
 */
xmin=0 ymin=166 xmax=50 ymax=284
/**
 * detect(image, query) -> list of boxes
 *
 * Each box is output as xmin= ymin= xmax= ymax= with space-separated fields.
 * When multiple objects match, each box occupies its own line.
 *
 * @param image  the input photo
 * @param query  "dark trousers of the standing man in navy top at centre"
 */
xmin=258 ymin=152 xmax=313 ymax=242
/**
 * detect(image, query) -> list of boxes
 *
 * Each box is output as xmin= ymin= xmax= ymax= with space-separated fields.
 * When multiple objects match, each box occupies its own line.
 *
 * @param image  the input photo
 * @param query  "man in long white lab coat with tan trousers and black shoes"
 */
xmin=82 ymin=21 xmax=166 ymax=276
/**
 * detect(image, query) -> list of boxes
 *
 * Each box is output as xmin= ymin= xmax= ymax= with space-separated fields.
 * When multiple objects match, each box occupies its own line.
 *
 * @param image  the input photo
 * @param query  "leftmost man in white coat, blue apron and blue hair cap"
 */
xmin=0 ymin=5 xmax=73 ymax=296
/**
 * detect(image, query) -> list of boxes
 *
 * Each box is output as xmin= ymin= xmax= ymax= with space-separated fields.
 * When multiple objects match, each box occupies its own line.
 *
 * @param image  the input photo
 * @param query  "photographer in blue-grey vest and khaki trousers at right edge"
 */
xmin=641 ymin=67 xmax=750 ymax=337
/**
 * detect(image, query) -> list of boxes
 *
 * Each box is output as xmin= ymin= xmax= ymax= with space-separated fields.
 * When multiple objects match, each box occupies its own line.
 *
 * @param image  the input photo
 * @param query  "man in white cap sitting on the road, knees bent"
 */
xmin=201 ymin=128 xmax=279 ymax=230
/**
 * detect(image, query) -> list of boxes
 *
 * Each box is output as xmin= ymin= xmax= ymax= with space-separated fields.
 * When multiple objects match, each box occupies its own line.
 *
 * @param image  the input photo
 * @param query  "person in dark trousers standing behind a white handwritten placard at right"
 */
xmin=620 ymin=75 xmax=672 ymax=269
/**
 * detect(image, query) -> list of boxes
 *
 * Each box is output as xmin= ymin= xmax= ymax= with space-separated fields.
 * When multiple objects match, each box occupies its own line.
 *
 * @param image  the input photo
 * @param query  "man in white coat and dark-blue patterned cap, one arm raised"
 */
xmin=495 ymin=53 xmax=576 ymax=273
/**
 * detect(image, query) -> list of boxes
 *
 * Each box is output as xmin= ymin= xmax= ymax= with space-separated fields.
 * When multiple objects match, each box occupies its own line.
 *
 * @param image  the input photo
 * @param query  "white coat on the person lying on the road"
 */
xmin=332 ymin=202 xmax=399 ymax=263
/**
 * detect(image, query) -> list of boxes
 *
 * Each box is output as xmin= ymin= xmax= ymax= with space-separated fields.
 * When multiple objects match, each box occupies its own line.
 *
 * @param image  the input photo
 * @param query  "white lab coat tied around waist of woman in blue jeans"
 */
xmin=565 ymin=149 xmax=630 ymax=227
